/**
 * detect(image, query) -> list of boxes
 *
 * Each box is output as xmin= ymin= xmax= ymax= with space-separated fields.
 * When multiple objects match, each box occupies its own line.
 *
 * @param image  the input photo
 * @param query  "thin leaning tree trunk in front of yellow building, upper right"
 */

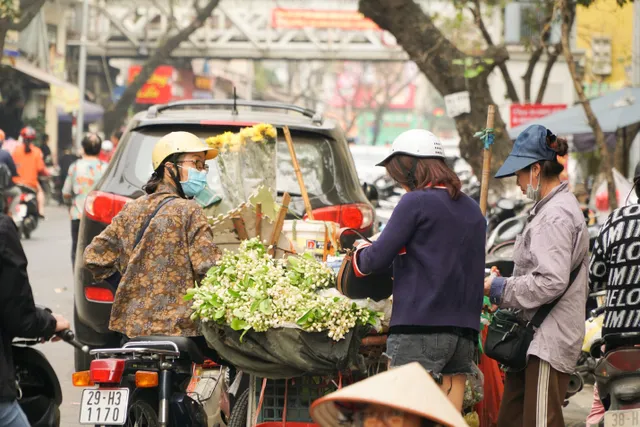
xmin=558 ymin=0 xmax=618 ymax=210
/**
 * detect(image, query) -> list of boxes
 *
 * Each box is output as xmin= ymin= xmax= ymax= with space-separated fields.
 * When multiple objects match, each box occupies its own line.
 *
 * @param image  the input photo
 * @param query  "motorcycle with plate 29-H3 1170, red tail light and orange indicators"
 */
xmin=73 ymin=336 xmax=232 ymax=427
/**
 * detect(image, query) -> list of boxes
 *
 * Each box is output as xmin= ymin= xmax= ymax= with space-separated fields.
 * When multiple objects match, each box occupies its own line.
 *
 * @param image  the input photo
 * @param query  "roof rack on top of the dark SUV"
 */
xmin=147 ymin=99 xmax=323 ymax=124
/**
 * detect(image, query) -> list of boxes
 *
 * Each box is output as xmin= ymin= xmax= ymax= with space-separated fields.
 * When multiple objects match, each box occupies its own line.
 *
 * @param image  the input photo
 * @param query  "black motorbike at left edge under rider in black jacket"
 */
xmin=11 ymin=310 xmax=89 ymax=427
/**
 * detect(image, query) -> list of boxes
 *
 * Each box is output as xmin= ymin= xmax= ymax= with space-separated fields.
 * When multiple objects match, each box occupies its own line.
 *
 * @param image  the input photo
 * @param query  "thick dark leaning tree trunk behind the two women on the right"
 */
xmin=359 ymin=0 xmax=511 ymax=179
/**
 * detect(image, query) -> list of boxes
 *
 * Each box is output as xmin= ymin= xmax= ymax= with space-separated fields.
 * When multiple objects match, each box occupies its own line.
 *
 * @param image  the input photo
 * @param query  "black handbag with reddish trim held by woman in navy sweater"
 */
xmin=336 ymin=229 xmax=393 ymax=301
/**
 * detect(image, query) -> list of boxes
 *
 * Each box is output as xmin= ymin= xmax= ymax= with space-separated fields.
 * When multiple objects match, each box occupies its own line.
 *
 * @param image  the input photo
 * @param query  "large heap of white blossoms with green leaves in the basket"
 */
xmin=185 ymin=239 xmax=381 ymax=341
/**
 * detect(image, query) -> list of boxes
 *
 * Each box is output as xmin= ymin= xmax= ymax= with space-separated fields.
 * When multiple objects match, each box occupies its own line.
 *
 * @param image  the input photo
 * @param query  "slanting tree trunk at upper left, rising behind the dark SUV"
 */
xmin=104 ymin=0 xmax=220 ymax=135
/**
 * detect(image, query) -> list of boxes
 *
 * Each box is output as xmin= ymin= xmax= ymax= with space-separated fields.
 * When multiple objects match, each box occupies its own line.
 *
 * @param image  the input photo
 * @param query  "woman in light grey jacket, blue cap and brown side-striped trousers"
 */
xmin=485 ymin=125 xmax=589 ymax=427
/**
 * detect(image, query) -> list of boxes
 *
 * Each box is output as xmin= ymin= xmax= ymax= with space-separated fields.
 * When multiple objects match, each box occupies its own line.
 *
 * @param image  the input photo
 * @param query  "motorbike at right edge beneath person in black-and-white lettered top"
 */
xmin=591 ymin=307 xmax=640 ymax=427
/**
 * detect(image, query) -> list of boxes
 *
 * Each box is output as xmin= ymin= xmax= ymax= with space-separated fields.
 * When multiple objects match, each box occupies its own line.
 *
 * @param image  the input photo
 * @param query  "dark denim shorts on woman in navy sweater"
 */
xmin=386 ymin=332 xmax=477 ymax=378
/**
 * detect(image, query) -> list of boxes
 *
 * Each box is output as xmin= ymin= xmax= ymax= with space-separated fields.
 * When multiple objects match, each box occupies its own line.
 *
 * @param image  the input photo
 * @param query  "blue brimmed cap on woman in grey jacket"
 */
xmin=496 ymin=125 xmax=557 ymax=178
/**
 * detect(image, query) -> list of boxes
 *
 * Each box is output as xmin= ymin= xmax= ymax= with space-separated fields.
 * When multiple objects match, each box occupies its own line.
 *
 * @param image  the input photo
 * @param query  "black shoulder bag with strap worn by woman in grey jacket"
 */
xmin=484 ymin=264 xmax=582 ymax=371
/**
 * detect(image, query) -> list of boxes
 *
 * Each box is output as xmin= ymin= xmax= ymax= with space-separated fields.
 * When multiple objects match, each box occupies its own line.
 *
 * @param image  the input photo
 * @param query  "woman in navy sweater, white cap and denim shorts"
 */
xmin=354 ymin=129 xmax=486 ymax=410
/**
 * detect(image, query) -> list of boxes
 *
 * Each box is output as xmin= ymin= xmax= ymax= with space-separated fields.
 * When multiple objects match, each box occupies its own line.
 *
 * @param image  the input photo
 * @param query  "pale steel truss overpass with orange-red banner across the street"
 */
xmin=69 ymin=0 xmax=407 ymax=61
